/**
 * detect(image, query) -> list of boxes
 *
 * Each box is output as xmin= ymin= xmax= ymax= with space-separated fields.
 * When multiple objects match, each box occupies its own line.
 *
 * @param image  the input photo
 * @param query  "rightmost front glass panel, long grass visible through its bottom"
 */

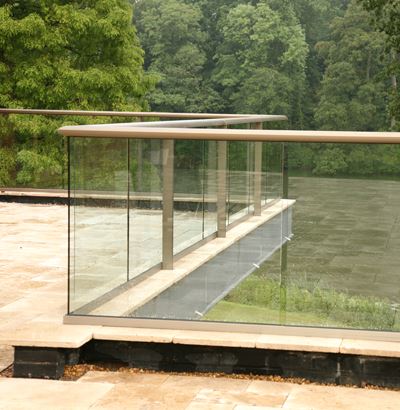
xmin=285 ymin=144 xmax=400 ymax=331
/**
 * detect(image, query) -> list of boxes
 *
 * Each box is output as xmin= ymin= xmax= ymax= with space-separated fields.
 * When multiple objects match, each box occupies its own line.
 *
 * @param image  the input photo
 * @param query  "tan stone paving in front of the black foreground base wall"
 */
xmin=0 ymin=371 xmax=400 ymax=410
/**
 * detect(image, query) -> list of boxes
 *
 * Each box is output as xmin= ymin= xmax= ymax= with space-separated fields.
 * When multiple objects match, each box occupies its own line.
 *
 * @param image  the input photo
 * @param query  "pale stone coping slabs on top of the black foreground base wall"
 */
xmin=0 ymin=322 xmax=400 ymax=358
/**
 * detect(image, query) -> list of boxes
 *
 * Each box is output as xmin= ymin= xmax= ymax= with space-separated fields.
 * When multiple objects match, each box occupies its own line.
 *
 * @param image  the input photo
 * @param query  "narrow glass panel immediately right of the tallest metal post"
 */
xmin=174 ymin=141 xmax=205 ymax=255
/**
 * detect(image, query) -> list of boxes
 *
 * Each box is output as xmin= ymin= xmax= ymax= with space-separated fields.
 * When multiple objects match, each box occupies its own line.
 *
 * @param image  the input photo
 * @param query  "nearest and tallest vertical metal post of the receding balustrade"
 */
xmin=162 ymin=140 xmax=174 ymax=270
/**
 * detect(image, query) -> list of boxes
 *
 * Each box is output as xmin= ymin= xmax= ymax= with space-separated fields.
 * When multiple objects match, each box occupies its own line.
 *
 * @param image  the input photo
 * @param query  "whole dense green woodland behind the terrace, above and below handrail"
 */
xmin=0 ymin=0 xmax=400 ymax=185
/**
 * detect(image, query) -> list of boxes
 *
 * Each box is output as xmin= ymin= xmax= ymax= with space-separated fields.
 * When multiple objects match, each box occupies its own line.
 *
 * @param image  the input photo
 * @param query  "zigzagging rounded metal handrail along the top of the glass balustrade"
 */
xmin=0 ymin=108 xmax=382 ymax=144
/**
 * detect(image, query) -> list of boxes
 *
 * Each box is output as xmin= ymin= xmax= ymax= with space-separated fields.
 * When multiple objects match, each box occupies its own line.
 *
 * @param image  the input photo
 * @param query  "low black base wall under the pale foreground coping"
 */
xmin=14 ymin=340 xmax=400 ymax=388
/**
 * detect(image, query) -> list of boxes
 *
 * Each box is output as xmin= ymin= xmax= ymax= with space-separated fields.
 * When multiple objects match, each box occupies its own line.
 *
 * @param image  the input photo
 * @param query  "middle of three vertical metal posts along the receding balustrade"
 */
xmin=217 ymin=141 xmax=228 ymax=238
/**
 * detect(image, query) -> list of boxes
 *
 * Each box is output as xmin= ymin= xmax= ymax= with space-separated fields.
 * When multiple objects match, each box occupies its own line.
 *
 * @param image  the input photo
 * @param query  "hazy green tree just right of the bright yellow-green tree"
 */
xmin=135 ymin=0 xmax=216 ymax=112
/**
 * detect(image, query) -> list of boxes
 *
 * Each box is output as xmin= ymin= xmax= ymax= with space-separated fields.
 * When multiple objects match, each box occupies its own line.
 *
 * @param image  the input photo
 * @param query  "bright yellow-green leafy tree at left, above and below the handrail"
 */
xmin=0 ymin=0 xmax=154 ymax=187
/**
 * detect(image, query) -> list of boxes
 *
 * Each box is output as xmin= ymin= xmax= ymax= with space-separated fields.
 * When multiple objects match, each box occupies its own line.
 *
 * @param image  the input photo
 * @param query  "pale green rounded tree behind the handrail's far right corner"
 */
xmin=213 ymin=0 xmax=308 ymax=127
